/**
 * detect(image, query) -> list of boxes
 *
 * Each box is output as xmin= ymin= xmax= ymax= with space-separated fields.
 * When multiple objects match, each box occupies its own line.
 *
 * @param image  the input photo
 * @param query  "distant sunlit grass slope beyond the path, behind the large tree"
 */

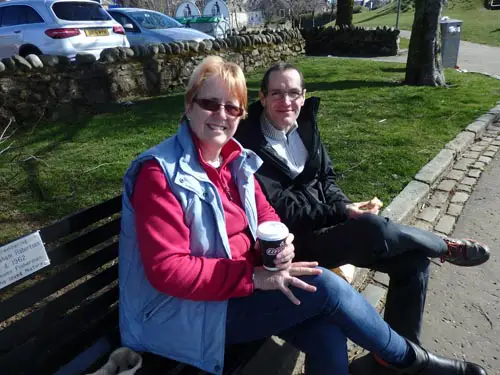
xmin=326 ymin=0 xmax=500 ymax=46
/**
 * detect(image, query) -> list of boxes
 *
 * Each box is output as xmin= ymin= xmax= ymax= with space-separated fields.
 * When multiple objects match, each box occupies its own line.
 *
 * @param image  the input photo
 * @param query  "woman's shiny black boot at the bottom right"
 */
xmin=390 ymin=340 xmax=488 ymax=375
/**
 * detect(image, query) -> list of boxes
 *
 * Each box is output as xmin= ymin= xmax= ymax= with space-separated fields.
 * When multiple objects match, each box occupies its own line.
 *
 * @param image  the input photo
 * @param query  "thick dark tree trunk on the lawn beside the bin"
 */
xmin=405 ymin=0 xmax=446 ymax=86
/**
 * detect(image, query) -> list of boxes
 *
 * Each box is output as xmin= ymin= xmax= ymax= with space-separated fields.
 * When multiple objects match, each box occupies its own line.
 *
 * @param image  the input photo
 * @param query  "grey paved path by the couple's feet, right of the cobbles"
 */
xmin=423 ymin=151 xmax=500 ymax=375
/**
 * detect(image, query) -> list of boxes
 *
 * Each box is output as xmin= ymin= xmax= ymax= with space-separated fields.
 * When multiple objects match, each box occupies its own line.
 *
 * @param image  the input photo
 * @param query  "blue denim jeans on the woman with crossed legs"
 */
xmin=226 ymin=269 xmax=408 ymax=375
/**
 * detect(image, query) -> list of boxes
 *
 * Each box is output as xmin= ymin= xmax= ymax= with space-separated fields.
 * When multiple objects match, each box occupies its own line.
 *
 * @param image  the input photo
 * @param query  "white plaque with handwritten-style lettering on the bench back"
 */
xmin=0 ymin=231 xmax=50 ymax=289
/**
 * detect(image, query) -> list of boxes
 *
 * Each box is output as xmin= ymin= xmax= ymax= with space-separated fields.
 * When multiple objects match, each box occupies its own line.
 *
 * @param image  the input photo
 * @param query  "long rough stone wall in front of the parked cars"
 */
xmin=0 ymin=29 xmax=305 ymax=125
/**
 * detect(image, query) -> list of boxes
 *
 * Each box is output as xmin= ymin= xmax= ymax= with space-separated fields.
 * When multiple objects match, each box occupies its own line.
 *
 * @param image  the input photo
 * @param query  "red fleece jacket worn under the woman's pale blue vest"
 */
xmin=132 ymin=141 xmax=279 ymax=301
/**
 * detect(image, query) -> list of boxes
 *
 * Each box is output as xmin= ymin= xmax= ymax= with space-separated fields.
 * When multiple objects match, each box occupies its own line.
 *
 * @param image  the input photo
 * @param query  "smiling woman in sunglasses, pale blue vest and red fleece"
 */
xmin=120 ymin=57 xmax=486 ymax=375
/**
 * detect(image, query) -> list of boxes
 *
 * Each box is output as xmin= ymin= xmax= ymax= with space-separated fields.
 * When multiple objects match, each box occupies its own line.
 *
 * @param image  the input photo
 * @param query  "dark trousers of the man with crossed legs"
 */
xmin=296 ymin=214 xmax=447 ymax=343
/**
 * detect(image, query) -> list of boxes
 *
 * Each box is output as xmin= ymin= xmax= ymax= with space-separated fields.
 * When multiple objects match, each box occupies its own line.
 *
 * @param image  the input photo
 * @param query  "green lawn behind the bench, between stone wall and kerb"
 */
xmin=0 ymin=57 xmax=500 ymax=243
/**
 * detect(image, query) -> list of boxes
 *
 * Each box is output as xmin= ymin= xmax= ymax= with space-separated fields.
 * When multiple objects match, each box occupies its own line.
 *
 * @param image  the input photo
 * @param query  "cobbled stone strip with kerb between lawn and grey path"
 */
xmin=240 ymin=102 xmax=500 ymax=375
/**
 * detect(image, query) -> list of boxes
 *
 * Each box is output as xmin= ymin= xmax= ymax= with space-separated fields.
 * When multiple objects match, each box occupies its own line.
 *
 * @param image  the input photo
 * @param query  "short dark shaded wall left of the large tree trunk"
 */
xmin=301 ymin=26 xmax=399 ymax=57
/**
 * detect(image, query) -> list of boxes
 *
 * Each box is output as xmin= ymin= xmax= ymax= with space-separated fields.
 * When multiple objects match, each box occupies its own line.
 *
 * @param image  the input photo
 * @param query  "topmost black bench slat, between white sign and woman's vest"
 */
xmin=40 ymin=195 xmax=122 ymax=242
